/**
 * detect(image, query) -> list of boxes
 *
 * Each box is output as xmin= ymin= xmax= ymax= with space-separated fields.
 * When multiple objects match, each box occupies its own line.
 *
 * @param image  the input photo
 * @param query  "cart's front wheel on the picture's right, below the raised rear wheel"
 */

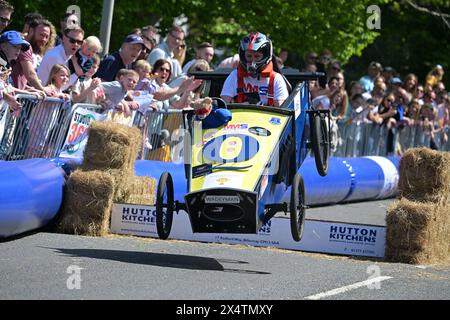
xmin=289 ymin=173 xmax=305 ymax=241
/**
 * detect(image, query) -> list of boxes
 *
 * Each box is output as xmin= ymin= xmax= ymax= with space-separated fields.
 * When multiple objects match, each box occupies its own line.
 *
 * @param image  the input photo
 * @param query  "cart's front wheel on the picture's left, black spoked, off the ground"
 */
xmin=156 ymin=172 xmax=174 ymax=240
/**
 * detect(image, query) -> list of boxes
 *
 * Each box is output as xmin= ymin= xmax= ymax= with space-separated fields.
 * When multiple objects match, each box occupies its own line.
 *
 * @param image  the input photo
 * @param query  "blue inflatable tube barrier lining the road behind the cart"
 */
xmin=0 ymin=157 xmax=400 ymax=238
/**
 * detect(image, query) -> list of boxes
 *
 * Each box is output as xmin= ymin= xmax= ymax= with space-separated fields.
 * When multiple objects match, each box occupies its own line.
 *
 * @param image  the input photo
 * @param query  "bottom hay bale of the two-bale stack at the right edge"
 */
xmin=385 ymin=198 xmax=450 ymax=264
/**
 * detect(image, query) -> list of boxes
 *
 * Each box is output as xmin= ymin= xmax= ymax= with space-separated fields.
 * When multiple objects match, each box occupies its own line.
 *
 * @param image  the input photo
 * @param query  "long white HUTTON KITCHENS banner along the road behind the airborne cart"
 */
xmin=111 ymin=204 xmax=386 ymax=257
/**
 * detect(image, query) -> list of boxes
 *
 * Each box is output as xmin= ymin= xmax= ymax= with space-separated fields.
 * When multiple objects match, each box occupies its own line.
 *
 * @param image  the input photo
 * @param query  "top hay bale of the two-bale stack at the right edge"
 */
xmin=398 ymin=148 xmax=450 ymax=205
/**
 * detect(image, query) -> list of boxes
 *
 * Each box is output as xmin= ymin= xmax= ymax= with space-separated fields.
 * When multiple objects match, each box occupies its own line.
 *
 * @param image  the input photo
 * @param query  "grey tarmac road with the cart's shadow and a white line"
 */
xmin=0 ymin=201 xmax=450 ymax=303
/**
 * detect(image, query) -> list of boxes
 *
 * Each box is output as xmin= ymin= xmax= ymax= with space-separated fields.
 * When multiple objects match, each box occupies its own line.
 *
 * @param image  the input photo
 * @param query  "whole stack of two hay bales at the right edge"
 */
xmin=385 ymin=148 xmax=450 ymax=264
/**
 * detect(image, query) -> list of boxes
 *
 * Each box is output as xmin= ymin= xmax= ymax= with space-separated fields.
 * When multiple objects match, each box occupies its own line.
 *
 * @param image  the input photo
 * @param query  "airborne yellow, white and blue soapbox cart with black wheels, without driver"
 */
xmin=156 ymin=71 xmax=330 ymax=241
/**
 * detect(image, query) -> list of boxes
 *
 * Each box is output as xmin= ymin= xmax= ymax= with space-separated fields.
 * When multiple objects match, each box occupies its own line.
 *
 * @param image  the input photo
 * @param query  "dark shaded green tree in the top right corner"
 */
xmin=345 ymin=1 xmax=450 ymax=87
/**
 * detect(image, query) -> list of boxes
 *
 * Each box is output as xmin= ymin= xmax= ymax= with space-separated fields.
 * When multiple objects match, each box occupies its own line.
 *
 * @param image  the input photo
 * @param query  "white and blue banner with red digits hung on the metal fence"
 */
xmin=60 ymin=108 xmax=107 ymax=158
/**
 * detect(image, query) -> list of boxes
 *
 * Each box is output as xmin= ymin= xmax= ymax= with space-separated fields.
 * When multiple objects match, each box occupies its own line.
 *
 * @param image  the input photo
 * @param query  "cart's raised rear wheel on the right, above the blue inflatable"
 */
xmin=310 ymin=113 xmax=330 ymax=177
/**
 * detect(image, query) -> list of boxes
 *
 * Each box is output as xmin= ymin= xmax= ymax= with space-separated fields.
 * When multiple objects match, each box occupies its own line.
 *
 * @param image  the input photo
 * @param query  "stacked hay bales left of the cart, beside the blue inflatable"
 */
xmin=57 ymin=122 xmax=156 ymax=236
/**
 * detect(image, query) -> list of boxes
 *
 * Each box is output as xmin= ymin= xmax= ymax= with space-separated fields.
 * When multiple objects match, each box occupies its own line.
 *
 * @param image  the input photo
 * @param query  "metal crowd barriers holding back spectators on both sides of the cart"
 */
xmin=0 ymin=95 xmax=450 ymax=163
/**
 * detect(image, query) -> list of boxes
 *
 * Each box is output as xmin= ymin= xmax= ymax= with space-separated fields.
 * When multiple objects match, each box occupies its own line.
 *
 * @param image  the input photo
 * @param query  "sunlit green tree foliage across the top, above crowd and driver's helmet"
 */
xmin=7 ymin=0 xmax=388 ymax=62
